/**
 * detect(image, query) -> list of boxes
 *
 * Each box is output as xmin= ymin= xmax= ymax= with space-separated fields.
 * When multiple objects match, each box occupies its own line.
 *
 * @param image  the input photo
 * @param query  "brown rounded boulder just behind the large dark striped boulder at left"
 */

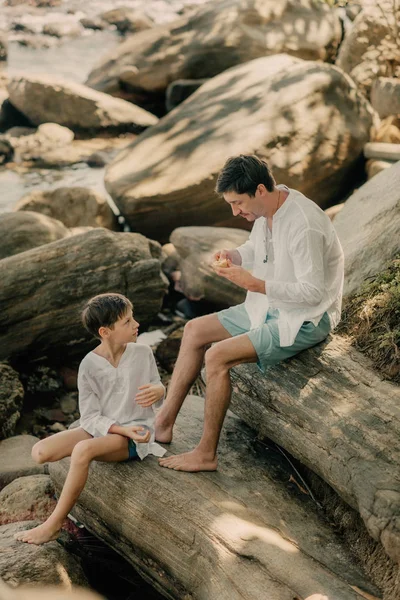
xmin=15 ymin=187 xmax=117 ymax=229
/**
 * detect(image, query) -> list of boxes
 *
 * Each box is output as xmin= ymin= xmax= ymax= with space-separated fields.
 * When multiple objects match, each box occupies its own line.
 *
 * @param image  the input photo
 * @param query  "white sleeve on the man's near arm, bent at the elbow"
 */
xmin=265 ymin=229 xmax=325 ymax=309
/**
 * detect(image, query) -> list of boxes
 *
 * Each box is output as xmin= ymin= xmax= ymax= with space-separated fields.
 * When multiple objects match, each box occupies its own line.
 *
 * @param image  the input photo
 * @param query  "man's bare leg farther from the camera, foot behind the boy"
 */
xmin=156 ymin=314 xmax=231 ymax=444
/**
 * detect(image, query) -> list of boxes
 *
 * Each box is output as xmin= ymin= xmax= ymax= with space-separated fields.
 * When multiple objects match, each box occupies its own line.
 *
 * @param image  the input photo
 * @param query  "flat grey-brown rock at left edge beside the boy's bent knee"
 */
xmin=0 ymin=435 xmax=45 ymax=489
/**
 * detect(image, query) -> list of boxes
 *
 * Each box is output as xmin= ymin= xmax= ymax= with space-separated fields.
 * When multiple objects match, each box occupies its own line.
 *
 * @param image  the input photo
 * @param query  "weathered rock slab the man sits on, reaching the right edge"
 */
xmin=231 ymin=336 xmax=400 ymax=568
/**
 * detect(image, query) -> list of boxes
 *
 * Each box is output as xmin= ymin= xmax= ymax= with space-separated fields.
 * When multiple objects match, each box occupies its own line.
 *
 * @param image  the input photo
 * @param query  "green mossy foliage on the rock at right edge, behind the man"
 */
xmin=338 ymin=256 xmax=400 ymax=383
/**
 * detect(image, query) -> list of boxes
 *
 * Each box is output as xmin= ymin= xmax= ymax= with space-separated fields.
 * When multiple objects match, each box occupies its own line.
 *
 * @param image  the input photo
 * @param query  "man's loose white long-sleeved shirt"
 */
xmin=237 ymin=185 xmax=344 ymax=347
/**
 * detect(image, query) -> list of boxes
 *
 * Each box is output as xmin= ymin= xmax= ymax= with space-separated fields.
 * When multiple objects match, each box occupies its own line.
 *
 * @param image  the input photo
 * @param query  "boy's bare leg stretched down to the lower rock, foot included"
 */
xmin=15 ymin=434 xmax=129 ymax=544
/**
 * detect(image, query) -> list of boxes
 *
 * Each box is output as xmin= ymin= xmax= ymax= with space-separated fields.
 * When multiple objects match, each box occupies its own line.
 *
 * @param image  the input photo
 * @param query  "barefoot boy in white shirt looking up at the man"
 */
xmin=15 ymin=294 xmax=165 ymax=544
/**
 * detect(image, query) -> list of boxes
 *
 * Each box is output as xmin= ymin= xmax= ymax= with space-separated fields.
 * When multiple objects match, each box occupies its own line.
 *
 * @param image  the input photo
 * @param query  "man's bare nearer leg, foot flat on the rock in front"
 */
xmin=159 ymin=335 xmax=257 ymax=472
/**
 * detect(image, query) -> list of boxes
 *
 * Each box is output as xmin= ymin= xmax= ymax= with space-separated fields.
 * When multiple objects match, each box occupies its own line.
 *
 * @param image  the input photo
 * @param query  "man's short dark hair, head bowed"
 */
xmin=215 ymin=154 xmax=275 ymax=196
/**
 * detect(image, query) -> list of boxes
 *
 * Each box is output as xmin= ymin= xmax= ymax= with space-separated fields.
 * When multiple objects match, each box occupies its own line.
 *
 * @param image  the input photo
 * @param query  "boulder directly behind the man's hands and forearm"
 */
xmin=171 ymin=227 xmax=249 ymax=307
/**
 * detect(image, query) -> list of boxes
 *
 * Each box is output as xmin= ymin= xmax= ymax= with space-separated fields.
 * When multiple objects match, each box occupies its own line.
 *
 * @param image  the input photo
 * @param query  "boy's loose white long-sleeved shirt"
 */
xmin=78 ymin=343 xmax=166 ymax=460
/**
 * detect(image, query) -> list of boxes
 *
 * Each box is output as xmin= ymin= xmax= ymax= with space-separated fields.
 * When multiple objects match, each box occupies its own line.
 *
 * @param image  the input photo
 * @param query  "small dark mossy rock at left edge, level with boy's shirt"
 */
xmin=0 ymin=363 xmax=24 ymax=440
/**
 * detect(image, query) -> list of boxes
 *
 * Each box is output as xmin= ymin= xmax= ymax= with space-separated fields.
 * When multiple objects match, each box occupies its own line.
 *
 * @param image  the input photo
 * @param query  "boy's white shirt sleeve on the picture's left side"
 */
xmin=78 ymin=370 xmax=116 ymax=437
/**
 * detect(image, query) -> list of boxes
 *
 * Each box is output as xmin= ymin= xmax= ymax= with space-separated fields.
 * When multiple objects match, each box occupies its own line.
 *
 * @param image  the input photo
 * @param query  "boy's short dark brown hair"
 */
xmin=82 ymin=294 xmax=133 ymax=339
